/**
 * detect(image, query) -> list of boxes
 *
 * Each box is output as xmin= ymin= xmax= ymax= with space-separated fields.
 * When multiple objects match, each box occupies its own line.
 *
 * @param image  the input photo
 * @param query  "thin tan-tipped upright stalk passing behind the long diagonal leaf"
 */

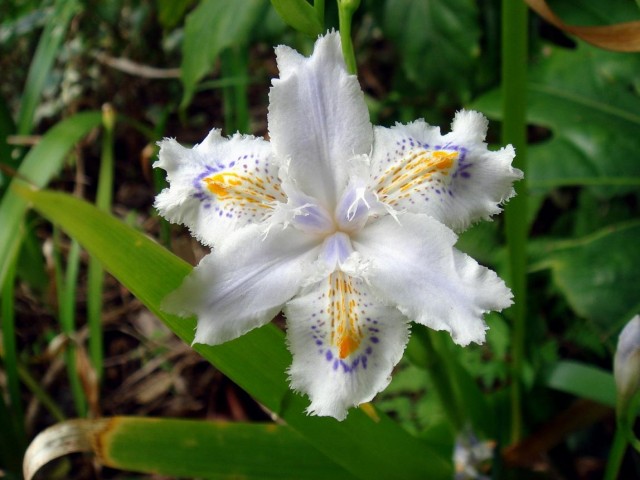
xmin=87 ymin=105 xmax=116 ymax=381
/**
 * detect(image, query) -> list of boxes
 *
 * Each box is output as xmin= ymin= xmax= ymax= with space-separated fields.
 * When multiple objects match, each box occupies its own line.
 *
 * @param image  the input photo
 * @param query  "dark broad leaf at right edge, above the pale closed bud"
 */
xmin=538 ymin=221 xmax=640 ymax=334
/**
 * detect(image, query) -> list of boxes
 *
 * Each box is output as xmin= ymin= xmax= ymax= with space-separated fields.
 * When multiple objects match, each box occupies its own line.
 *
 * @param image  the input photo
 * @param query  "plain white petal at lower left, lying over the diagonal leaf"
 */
xmin=162 ymin=225 xmax=319 ymax=345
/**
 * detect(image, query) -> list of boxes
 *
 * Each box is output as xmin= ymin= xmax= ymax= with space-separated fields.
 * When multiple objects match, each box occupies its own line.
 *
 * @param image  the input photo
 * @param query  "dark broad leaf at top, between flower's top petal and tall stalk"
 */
xmin=383 ymin=0 xmax=480 ymax=99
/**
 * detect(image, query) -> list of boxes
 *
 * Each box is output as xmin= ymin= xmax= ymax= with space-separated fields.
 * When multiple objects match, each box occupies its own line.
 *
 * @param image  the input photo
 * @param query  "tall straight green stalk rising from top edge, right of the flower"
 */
xmin=502 ymin=0 xmax=528 ymax=442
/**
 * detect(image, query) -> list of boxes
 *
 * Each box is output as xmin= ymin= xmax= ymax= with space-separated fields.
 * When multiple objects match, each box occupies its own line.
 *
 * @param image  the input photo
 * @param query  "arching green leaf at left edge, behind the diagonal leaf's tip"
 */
xmin=0 ymin=112 xmax=102 ymax=285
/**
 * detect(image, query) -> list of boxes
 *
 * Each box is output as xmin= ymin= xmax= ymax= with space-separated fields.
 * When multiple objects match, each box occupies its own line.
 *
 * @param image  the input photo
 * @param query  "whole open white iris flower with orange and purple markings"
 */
xmin=155 ymin=33 xmax=522 ymax=420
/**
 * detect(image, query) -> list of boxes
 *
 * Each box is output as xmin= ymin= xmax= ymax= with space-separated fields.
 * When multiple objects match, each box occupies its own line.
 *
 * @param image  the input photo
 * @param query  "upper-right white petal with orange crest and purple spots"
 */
xmin=370 ymin=111 xmax=522 ymax=231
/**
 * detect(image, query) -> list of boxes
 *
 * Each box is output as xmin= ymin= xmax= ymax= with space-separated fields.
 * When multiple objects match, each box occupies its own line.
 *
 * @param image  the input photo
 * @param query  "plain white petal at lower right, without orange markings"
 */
xmin=353 ymin=213 xmax=512 ymax=345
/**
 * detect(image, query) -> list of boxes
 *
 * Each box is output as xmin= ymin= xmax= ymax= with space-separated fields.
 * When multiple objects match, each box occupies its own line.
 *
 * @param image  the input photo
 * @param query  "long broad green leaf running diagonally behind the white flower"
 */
xmin=20 ymin=186 xmax=452 ymax=479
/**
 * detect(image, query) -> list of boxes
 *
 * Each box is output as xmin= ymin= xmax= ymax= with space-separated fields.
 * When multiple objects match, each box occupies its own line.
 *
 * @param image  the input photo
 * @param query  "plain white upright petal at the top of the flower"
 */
xmin=269 ymin=33 xmax=373 ymax=210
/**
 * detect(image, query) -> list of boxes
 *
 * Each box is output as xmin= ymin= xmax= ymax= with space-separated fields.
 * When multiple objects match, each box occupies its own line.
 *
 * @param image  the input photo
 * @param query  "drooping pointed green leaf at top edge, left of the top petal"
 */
xmin=180 ymin=0 xmax=268 ymax=109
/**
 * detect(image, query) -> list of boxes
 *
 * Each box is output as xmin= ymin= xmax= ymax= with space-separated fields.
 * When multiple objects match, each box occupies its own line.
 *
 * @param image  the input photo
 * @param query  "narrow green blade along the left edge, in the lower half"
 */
xmin=0 ymin=253 xmax=26 ymax=445
